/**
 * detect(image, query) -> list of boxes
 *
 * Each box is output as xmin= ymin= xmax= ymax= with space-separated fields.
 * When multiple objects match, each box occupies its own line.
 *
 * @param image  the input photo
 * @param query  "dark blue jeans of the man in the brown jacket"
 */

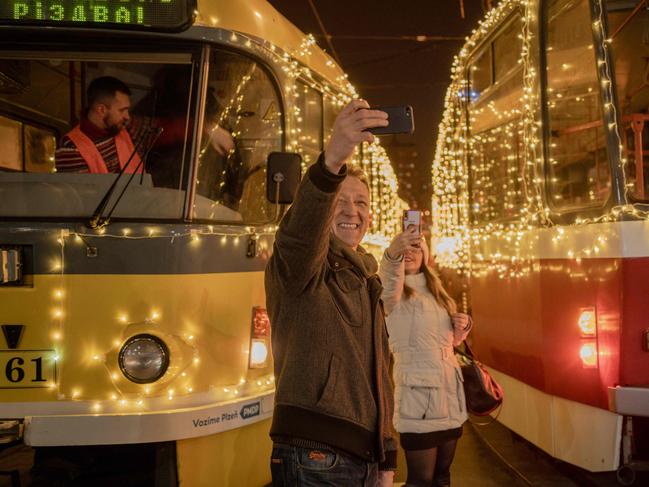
xmin=270 ymin=443 xmax=379 ymax=487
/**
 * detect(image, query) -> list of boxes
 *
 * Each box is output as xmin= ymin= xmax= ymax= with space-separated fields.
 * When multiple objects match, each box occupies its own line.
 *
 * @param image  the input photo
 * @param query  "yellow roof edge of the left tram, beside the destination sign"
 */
xmin=194 ymin=0 xmax=345 ymax=84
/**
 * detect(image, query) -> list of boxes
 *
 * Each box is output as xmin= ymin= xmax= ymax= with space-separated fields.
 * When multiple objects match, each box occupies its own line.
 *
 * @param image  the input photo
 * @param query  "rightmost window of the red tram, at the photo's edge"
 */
xmin=606 ymin=0 xmax=649 ymax=201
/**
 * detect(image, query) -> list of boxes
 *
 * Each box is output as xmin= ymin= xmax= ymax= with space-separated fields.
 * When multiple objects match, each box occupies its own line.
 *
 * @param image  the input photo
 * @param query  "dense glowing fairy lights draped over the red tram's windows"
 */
xmin=432 ymin=0 xmax=649 ymax=277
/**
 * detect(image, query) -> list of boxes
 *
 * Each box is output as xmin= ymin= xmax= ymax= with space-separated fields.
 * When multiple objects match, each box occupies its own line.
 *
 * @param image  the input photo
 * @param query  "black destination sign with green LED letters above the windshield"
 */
xmin=0 ymin=0 xmax=196 ymax=31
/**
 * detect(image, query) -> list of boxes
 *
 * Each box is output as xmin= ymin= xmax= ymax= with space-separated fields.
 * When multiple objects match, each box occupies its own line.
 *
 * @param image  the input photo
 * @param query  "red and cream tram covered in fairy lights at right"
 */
xmin=433 ymin=0 xmax=649 ymax=483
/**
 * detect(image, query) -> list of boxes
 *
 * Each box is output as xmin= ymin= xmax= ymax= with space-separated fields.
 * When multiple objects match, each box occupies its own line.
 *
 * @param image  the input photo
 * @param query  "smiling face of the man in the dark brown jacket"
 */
xmin=333 ymin=176 xmax=370 ymax=250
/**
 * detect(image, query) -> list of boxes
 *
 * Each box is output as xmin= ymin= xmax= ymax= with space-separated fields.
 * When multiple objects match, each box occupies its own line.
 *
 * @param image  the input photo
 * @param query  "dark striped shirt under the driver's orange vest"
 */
xmin=55 ymin=117 xmax=147 ymax=173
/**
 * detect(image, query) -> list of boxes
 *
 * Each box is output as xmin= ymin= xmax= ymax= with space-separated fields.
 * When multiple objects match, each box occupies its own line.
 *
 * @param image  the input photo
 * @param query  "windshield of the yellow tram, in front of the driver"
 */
xmin=0 ymin=46 xmax=282 ymax=222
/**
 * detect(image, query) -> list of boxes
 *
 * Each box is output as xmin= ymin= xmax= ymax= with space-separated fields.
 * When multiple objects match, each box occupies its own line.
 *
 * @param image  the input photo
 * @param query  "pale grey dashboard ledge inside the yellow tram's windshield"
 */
xmin=0 ymin=172 xmax=241 ymax=221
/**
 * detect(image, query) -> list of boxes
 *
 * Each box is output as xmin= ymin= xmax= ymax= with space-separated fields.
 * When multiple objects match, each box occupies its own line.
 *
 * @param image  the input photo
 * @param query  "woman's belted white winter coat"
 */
xmin=379 ymin=254 xmax=471 ymax=433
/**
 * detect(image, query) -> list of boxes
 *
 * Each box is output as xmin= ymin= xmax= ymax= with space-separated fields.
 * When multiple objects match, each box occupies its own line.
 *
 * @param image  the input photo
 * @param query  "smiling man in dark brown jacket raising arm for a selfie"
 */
xmin=266 ymin=100 xmax=396 ymax=486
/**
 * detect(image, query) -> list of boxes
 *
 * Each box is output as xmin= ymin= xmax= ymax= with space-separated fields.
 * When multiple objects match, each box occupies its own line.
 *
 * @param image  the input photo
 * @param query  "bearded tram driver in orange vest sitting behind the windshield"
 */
xmin=55 ymin=76 xmax=149 ymax=174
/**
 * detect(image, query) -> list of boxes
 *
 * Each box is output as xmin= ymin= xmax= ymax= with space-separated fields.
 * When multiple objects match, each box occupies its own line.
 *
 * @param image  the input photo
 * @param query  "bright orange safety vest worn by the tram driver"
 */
xmin=66 ymin=125 xmax=142 ymax=174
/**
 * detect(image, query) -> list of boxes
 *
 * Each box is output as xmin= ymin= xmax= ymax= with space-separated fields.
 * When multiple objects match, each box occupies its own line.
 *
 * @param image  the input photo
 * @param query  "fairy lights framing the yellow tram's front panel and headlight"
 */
xmin=45 ymin=226 xmax=276 ymax=413
